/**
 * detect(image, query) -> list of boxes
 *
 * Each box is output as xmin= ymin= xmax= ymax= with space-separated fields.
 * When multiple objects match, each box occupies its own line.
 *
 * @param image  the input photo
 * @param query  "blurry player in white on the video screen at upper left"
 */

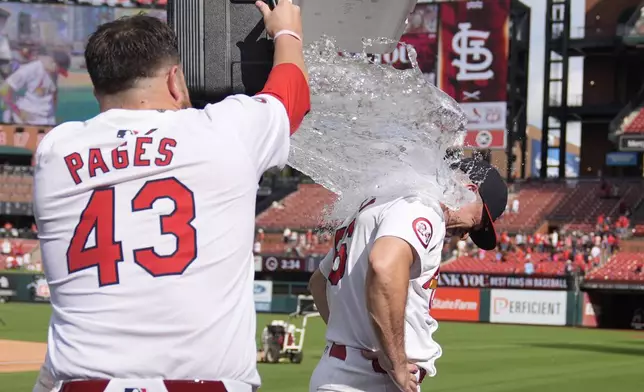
xmin=0 ymin=50 xmax=71 ymax=125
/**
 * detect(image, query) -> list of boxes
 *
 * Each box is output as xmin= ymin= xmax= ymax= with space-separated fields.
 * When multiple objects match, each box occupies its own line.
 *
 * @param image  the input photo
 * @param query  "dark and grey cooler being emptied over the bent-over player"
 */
xmin=167 ymin=0 xmax=417 ymax=106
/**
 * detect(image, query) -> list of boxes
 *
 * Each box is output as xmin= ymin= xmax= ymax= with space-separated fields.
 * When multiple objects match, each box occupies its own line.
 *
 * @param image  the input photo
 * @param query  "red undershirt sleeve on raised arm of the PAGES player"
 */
xmin=258 ymin=63 xmax=311 ymax=135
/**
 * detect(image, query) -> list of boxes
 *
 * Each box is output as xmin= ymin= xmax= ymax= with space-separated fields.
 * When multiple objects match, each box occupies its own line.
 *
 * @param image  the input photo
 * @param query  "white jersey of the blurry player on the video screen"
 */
xmin=6 ymin=59 xmax=57 ymax=125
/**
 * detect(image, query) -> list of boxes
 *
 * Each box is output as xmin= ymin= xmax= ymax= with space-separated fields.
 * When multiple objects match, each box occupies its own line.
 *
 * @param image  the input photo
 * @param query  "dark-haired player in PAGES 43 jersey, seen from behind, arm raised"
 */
xmin=34 ymin=1 xmax=310 ymax=392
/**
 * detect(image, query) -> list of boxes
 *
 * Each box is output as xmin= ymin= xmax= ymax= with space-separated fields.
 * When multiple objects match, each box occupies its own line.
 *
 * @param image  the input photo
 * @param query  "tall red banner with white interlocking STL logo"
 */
xmin=438 ymin=0 xmax=510 ymax=149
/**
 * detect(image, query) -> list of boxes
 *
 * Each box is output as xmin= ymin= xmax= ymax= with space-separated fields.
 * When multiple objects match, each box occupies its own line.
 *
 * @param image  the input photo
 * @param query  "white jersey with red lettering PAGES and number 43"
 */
xmin=34 ymin=95 xmax=289 ymax=385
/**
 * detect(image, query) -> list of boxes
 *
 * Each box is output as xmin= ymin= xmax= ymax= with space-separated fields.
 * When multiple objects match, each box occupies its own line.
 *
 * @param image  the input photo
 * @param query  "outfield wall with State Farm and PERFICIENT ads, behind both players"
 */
xmin=0 ymin=272 xmax=644 ymax=329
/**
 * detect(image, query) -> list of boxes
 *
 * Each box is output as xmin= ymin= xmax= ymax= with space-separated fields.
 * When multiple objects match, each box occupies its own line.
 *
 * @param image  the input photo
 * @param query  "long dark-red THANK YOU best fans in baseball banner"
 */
xmin=438 ymin=272 xmax=569 ymax=290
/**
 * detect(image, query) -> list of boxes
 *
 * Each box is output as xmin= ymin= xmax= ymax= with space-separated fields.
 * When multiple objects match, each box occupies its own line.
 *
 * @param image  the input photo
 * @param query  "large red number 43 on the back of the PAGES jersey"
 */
xmin=67 ymin=177 xmax=197 ymax=286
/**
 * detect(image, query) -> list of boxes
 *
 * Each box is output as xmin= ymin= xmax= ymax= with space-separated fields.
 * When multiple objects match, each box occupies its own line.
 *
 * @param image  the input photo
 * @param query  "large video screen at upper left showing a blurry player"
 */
xmin=0 ymin=1 xmax=166 ymax=126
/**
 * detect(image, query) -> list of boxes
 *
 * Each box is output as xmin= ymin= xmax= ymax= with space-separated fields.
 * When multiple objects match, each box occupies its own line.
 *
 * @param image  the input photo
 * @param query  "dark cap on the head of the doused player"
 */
xmin=454 ymin=158 xmax=508 ymax=250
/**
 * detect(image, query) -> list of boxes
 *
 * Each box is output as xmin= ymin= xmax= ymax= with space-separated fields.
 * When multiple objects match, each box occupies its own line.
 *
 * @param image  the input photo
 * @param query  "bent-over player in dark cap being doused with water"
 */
xmin=310 ymin=159 xmax=508 ymax=392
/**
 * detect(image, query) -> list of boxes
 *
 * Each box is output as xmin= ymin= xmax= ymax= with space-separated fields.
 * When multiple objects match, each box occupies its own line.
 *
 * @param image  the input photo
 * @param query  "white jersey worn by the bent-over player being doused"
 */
xmin=320 ymin=198 xmax=445 ymax=376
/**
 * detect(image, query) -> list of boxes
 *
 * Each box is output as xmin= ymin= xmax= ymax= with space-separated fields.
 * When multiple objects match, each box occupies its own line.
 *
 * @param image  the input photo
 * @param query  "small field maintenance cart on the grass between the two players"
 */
xmin=257 ymin=295 xmax=320 ymax=363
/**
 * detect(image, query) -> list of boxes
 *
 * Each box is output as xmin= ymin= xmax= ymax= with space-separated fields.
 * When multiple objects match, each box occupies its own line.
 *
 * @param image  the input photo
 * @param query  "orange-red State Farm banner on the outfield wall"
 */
xmin=429 ymin=287 xmax=481 ymax=321
